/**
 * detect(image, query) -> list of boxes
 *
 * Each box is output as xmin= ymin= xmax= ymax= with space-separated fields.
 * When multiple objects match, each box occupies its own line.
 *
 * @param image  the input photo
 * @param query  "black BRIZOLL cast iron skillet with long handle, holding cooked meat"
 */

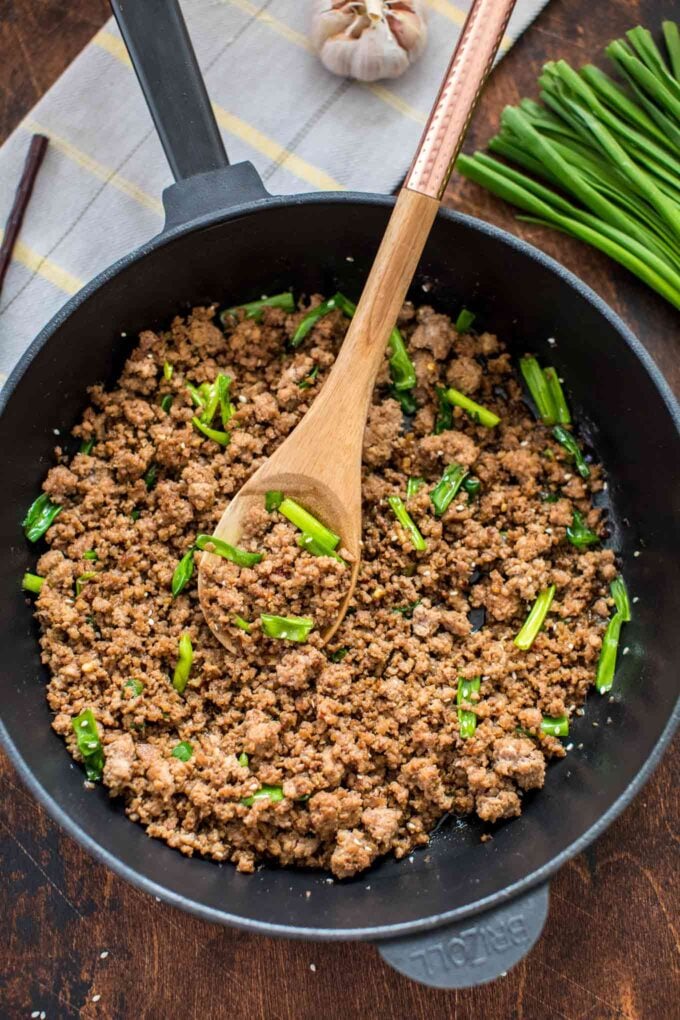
xmin=0 ymin=0 xmax=680 ymax=987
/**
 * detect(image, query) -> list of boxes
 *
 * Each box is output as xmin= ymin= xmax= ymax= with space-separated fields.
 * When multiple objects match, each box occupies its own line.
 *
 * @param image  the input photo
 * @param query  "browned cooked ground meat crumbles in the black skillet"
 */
xmin=29 ymin=298 xmax=616 ymax=877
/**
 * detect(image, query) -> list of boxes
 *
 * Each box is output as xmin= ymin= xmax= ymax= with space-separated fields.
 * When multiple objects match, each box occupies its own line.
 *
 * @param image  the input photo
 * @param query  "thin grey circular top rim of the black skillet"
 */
xmin=0 ymin=192 xmax=680 ymax=941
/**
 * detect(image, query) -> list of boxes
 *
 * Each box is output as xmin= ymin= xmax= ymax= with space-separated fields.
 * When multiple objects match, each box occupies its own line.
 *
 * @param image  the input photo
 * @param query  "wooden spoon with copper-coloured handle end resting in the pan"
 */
xmin=199 ymin=0 xmax=515 ymax=647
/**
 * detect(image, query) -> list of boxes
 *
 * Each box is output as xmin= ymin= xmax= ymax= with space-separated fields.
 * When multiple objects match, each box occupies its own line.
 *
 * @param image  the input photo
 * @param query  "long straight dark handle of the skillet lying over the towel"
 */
xmin=111 ymin=0 xmax=229 ymax=181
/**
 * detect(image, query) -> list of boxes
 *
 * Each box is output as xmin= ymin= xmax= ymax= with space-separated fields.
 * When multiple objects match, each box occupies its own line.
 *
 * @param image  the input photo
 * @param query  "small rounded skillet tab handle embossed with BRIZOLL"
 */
xmin=377 ymin=884 xmax=548 ymax=988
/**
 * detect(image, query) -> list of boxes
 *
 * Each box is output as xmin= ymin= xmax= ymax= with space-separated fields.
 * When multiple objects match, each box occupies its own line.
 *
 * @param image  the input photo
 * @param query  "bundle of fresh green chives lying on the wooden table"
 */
xmin=457 ymin=21 xmax=680 ymax=308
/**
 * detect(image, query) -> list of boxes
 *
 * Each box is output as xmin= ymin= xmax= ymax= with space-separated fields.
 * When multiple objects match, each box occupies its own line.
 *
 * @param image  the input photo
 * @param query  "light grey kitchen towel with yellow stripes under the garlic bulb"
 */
xmin=0 ymin=0 xmax=546 ymax=381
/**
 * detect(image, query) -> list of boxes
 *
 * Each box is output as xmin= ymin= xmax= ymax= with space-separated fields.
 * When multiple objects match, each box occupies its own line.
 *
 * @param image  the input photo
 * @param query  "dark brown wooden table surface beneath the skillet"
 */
xmin=0 ymin=0 xmax=680 ymax=1020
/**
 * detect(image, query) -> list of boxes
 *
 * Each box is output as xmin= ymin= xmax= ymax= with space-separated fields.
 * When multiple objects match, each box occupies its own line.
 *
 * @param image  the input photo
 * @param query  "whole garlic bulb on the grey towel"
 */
xmin=312 ymin=0 xmax=427 ymax=82
